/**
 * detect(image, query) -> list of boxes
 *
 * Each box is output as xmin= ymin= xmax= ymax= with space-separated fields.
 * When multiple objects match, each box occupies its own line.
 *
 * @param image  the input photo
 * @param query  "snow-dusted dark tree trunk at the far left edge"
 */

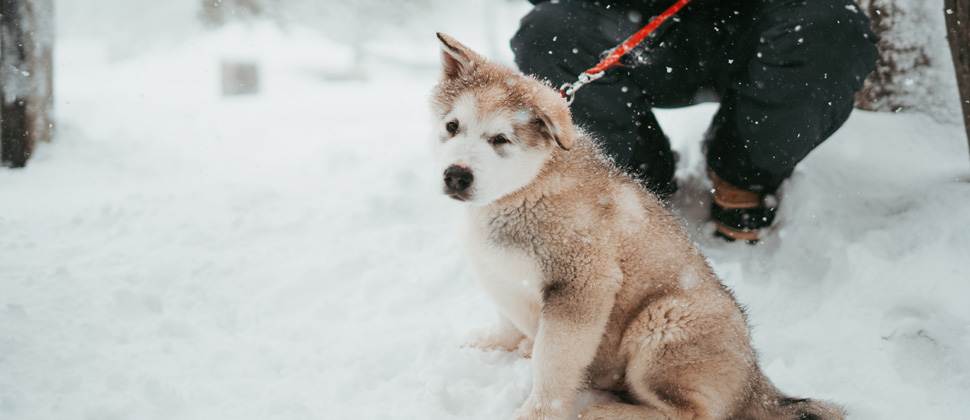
xmin=0 ymin=0 xmax=54 ymax=167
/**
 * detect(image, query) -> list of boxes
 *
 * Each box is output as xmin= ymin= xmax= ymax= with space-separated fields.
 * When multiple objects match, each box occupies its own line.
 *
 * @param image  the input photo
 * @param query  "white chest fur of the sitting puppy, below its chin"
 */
xmin=462 ymin=210 xmax=542 ymax=338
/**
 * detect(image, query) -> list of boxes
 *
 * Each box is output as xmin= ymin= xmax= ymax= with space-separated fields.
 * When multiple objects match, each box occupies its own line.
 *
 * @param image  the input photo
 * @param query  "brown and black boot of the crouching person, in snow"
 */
xmin=710 ymin=172 xmax=775 ymax=243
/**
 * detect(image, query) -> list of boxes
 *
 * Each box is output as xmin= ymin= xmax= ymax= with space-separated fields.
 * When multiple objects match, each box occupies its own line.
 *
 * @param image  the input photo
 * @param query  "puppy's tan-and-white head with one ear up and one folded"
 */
xmin=431 ymin=33 xmax=573 ymax=205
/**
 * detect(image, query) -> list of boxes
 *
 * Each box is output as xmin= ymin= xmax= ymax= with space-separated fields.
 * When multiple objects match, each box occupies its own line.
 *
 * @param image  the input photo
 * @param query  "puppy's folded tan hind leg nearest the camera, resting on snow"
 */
xmin=608 ymin=295 xmax=756 ymax=420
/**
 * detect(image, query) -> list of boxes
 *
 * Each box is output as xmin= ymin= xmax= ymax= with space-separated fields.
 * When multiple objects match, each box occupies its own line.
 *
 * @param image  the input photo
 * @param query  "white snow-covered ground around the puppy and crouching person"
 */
xmin=0 ymin=2 xmax=970 ymax=420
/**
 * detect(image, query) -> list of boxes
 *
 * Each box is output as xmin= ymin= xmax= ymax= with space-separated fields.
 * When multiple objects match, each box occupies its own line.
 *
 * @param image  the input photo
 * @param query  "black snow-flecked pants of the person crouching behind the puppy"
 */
xmin=511 ymin=0 xmax=878 ymax=193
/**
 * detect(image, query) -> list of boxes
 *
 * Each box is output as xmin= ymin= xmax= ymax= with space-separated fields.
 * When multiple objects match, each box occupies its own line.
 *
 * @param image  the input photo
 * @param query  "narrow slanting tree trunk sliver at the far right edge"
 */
xmin=943 ymin=0 xmax=970 ymax=160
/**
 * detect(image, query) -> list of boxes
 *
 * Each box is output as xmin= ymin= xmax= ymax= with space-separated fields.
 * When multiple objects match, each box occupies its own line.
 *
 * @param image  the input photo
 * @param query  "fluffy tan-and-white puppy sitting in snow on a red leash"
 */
xmin=431 ymin=34 xmax=844 ymax=420
